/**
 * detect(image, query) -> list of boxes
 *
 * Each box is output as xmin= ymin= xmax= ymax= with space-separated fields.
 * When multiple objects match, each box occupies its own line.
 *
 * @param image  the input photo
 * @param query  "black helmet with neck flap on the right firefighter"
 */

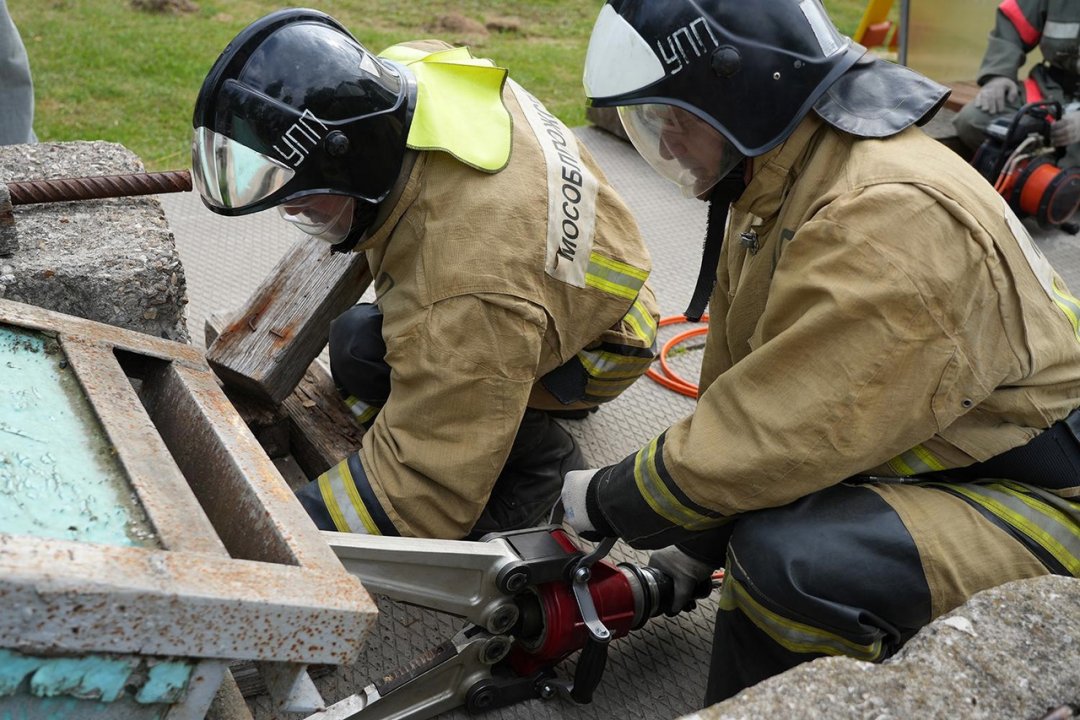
xmin=584 ymin=0 xmax=948 ymax=196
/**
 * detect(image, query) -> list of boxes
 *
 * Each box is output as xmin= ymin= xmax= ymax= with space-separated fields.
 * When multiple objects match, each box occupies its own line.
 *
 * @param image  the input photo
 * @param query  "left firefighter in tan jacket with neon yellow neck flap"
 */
xmin=192 ymin=10 xmax=658 ymax=539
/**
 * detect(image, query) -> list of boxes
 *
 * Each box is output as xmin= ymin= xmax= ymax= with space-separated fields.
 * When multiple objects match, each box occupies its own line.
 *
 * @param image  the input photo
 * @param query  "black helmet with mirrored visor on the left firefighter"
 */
xmin=191 ymin=9 xmax=416 ymax=247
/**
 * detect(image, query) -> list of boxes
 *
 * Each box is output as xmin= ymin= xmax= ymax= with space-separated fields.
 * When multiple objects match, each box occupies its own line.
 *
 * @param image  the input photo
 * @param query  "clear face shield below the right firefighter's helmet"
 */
xmin=619 ymin=105 xmax=743 ymax=198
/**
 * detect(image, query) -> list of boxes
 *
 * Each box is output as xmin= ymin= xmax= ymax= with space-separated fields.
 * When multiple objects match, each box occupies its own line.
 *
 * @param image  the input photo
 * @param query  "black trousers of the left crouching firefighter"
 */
xmin=300 ymin=303 xmax=585 ymax=539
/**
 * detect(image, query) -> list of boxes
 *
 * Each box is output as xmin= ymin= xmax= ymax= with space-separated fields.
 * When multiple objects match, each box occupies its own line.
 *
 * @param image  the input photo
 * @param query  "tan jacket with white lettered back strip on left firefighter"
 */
xmin=341 ymin=74 xmax=658 ymax=538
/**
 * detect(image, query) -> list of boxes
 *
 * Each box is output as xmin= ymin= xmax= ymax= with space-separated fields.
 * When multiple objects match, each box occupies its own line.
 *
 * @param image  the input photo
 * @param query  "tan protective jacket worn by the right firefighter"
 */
xmin=599 ymin=116 xmax=1080 ymax=546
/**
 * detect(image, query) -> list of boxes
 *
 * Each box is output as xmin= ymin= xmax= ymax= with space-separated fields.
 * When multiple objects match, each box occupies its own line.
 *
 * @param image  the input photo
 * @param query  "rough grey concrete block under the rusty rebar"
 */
xmin=0 ymin=141 xmax=188 ymax=342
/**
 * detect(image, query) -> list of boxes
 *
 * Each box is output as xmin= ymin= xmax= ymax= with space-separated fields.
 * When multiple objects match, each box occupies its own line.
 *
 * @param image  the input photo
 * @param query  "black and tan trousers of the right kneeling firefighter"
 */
xmin=693 ymin=480 xmax=1080 ymax=706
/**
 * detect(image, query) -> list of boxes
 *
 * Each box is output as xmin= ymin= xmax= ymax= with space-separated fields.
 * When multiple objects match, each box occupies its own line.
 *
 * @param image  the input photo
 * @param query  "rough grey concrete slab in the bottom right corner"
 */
xmin=684 ymin=575 xmax=1080 ymax=720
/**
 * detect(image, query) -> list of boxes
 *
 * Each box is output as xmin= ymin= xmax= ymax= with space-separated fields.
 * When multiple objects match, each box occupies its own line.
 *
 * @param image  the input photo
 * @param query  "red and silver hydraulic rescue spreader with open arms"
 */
xmin=308 ymin=526 xmax=711 ymax=720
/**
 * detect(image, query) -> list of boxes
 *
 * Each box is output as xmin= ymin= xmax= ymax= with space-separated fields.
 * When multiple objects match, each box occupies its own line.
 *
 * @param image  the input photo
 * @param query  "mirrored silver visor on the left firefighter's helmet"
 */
xmin=191 ymin=127 xmax=296 ymax=209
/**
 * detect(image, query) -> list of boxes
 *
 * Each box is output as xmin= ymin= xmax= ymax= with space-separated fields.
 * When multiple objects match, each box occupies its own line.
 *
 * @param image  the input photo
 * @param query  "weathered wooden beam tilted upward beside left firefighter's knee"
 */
xmin=206 ymin=239 xmax=372 ymax=405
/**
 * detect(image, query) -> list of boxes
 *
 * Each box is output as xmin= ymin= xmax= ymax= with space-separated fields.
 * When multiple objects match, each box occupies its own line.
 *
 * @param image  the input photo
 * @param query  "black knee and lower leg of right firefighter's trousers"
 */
xmin=699 ymin=485 xmax=932 ymax=703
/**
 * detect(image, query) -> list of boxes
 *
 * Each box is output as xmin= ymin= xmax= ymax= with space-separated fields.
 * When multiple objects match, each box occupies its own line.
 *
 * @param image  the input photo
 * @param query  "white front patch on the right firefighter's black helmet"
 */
xmin=584 ymin=4 xmax=665 ymax=97
